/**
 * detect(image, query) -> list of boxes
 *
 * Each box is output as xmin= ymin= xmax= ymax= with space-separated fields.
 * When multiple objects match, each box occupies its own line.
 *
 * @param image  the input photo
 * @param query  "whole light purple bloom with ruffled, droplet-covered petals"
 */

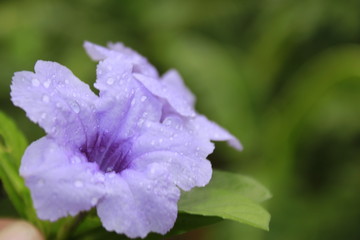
xmin=11 ymin=42 xmax=241 ymax=237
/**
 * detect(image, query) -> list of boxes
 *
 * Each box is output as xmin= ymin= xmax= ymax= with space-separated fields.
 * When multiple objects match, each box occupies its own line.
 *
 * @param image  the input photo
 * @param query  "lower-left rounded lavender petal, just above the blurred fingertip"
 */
xmin=20 ymin=137 xmax=104 ymax=221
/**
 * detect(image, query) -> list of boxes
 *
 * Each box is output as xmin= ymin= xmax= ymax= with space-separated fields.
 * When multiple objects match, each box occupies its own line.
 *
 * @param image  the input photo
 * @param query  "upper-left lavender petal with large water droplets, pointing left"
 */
xmin=11 ymin=61 xmax=97 ymax=144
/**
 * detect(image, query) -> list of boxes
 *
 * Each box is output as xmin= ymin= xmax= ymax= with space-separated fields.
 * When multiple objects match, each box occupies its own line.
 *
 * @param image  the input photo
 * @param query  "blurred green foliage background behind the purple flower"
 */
xmin=0 ymin=0 xmax=360 ymax=240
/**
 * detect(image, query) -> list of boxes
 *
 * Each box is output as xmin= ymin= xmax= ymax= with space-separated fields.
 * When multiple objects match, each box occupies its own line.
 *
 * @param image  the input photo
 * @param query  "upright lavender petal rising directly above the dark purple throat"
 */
xmin=95 ymin=56 xmax=162 ymax=138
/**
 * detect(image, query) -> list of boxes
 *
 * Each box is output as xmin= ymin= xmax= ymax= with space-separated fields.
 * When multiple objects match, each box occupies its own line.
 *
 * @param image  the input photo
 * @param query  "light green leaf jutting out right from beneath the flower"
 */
xmin=179 ymin=171 xmax=271 ymax=230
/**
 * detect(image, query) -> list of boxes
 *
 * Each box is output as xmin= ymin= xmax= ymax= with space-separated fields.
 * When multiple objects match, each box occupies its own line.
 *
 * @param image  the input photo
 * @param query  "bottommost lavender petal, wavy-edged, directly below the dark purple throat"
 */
xmin=97 ymin=168 xmax=180 ymax=238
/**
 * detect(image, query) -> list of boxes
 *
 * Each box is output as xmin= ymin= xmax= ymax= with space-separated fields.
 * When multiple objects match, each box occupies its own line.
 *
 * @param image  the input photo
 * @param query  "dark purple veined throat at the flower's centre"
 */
xmin=80 ymin=134 xmax=132 ymax=173
